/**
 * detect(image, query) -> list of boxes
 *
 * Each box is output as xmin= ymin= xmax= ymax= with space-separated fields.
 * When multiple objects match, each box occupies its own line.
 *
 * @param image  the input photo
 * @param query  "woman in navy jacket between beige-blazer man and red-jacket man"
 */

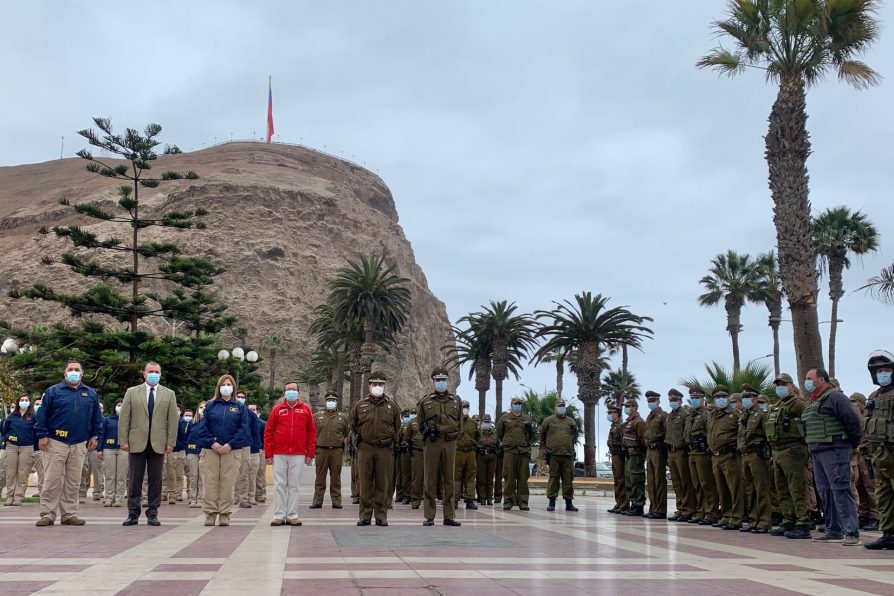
xmin=193 ymin=375 xmax=251 ymax=526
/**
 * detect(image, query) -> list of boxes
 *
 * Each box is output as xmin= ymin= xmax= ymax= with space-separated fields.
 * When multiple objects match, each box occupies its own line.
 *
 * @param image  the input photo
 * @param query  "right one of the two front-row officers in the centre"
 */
xmin=416 ymin=366 xmax=462 ymax=526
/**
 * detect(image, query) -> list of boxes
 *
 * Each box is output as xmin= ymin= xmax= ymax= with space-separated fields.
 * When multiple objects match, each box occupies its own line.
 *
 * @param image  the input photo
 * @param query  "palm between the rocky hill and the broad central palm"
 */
xmin=469 ymin=300 xmax=537 ymax=420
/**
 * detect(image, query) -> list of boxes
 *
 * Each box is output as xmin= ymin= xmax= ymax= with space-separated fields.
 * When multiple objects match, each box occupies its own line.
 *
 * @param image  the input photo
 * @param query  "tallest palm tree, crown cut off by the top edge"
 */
xmin=697 ymin=0 xmax=879 ymax=386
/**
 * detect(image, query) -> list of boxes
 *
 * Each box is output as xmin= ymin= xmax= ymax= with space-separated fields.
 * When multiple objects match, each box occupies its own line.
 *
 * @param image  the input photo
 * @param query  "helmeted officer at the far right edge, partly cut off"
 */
xmin=863 ymin=350 xmax=894 ymax=550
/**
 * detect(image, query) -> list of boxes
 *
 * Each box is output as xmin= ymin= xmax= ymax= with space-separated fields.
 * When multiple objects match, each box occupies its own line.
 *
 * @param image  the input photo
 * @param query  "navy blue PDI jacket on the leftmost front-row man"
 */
xmin=34 ymin=381 xmax=102 ymax=445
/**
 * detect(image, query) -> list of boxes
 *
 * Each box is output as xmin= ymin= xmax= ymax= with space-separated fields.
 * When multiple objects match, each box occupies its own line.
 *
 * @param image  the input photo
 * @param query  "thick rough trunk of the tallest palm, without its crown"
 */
xmin=764 ymin=74 xmax=823 ymax=382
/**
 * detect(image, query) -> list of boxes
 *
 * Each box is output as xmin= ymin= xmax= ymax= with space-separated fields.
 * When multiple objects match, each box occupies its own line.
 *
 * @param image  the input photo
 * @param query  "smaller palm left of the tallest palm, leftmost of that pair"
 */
xmin=698 ymin=250 xmax=761 ymax=370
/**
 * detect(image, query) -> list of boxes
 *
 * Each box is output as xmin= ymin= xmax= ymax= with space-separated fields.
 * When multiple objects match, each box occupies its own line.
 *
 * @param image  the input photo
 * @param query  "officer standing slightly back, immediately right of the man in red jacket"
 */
xmin=310 ymin=391 xmax=348 ymax=509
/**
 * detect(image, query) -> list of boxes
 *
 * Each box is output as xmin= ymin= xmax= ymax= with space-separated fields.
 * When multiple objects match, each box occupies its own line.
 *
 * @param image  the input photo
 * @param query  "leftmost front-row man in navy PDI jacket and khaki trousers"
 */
xmin=34 ymin=362 xmax=102 ymax=526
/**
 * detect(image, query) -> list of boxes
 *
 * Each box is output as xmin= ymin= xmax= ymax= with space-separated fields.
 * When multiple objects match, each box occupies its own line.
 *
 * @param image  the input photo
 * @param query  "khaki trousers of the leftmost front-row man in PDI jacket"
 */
xmin=40 ymin=439 xmax=87 ymax=521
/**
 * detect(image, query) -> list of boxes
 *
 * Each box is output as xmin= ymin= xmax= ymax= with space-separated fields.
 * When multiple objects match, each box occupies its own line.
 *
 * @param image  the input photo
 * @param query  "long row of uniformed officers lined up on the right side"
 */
xmin=607 ymin=351 xmax=894 ymax=549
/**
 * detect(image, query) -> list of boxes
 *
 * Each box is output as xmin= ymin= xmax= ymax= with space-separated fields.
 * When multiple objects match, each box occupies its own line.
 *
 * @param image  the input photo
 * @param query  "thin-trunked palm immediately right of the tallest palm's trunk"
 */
xmin=813 ymin=207 xmax=878 ymax=377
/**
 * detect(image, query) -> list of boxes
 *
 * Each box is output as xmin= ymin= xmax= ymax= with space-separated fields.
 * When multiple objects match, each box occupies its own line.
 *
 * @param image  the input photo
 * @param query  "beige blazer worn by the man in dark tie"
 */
xmin=118 ymin=383 xmax=177 ymax=453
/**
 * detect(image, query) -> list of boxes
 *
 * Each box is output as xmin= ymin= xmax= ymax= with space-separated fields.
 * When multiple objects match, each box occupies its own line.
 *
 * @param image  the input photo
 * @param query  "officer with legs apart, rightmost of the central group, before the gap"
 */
xmin=540 ymin=399 xmax=578 ymax=511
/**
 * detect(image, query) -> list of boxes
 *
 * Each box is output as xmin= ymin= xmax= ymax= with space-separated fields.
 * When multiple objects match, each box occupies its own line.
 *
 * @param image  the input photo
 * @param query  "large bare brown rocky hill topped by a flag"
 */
xmin=0 ymin=143 xmax=456 ymax=405
